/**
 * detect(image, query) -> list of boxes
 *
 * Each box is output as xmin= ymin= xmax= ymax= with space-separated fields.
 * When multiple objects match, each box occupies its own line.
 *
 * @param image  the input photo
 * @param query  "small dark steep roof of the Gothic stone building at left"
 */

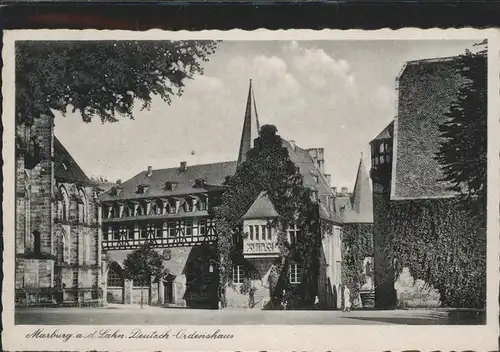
xmin=54 ymin=137 xmax=93 ymax=185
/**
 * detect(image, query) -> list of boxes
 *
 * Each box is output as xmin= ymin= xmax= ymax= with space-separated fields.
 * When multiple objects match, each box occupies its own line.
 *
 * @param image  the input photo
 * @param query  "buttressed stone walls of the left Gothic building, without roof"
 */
xmin=16 ymin=116 xmax=100 ymax=304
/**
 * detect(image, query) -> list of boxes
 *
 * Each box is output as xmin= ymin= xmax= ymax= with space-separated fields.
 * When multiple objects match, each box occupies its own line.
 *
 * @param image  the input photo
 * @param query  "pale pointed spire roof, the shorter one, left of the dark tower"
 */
xmin=352 ymin=153 xmax=373 ymax=222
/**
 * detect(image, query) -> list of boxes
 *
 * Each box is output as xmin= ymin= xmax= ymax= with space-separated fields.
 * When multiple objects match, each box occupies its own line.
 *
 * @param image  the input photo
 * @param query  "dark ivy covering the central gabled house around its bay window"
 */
xmin=214 ymin=125 xmax=319 ymax=303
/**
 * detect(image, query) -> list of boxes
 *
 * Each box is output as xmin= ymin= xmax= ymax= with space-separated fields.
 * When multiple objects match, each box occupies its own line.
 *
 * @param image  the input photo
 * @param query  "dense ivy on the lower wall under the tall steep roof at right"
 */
xmin=388 ymin=199 xmax=486 ymax=308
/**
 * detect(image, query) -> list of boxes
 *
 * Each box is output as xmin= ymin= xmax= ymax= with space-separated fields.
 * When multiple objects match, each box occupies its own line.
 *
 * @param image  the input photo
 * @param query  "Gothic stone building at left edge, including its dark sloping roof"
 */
xmin=15 ymin=115 xmax=101 ymax=305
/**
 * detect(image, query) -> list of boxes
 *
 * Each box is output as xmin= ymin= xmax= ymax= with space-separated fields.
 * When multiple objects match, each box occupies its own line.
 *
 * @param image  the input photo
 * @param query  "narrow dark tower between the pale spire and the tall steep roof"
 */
xmin=370 ymin=122 xmax=397 ymax=309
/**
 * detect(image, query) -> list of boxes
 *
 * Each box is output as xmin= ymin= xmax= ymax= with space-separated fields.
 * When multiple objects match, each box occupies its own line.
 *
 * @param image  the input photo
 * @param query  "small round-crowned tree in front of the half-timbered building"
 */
xmin=123 ymin=245 xmax=168 ymax=308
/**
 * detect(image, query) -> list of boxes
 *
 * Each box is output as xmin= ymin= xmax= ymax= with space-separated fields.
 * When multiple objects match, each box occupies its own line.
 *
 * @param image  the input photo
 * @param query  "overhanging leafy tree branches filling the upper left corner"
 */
xmin=16 ymin=41 xmax=216 ymax=122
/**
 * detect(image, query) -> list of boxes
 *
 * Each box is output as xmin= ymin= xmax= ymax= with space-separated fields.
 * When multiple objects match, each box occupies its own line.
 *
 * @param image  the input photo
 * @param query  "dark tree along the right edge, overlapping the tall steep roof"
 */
xmin=435 ymin=42 xmax=487 ymax=226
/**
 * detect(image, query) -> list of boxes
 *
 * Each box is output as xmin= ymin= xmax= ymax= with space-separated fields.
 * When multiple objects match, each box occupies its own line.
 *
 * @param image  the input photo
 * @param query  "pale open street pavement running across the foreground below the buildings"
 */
xmin=16 ymin=306 xmax=478 ymax=325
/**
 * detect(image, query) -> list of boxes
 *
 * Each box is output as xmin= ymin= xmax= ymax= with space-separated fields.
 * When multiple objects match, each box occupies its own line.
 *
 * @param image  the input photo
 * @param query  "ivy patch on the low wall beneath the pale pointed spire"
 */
xmin=342 ymin=224 xmax=374 ymax=298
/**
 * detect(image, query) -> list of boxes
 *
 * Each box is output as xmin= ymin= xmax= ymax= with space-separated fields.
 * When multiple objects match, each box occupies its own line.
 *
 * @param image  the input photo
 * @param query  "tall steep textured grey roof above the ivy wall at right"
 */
xmin=391 ymin=57 xmax=461 ymax=199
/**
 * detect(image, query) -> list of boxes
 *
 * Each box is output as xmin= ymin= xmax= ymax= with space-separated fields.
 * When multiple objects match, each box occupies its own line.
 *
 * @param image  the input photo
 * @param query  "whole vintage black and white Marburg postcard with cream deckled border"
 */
xmin=2 ymin=29 xmax=500 ymax=351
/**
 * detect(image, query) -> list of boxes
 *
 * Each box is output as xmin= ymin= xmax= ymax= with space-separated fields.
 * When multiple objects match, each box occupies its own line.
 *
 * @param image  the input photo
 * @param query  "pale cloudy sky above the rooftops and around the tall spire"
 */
xmin=55 ymin=40 xmax=474 ymax=189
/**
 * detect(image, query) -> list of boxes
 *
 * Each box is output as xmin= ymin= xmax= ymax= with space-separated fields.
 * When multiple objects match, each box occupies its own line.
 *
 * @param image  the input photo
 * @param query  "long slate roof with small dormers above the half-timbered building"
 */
xmin=99 ymin=161 xmax=236 ymax=201
